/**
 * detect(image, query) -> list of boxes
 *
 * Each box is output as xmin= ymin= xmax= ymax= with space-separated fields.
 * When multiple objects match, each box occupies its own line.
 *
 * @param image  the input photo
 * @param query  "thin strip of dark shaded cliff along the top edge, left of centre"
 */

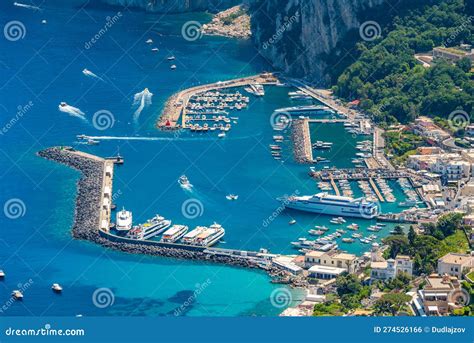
xmin=101 ymin=0 xmax=246 ymax=13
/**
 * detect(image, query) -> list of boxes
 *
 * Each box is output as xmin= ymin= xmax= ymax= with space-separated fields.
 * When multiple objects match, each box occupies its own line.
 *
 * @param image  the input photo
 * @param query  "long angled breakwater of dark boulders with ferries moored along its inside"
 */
xmin=38 ymin=147 xmax=304 ymax=286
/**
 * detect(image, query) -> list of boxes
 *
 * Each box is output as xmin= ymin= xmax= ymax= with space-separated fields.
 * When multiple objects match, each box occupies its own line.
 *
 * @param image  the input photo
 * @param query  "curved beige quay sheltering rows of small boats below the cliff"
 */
xmin=157 ymin=73 xmax=278 ymax=130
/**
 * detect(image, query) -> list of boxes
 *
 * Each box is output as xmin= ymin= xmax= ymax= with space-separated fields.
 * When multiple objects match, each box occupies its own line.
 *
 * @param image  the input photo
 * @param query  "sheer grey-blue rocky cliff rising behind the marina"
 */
xmin=251 ymin=0 xmax=385 ymax=83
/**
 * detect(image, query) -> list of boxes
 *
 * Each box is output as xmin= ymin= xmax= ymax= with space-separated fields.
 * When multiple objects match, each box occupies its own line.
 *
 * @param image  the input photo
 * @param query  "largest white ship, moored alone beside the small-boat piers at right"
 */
xmin=279 ymin=193 xmax=379 ymax=219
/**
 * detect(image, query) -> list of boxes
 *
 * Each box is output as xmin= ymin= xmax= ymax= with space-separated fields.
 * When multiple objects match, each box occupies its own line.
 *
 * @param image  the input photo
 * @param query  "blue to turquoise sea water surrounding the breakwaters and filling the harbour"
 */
xmin=0 ymin=1 xmax=412 ymax=316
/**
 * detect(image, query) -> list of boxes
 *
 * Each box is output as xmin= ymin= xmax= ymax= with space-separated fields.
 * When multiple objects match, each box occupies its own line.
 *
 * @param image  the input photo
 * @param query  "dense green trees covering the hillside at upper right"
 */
xmin=334 ymin=0 xmax=474 ymax=124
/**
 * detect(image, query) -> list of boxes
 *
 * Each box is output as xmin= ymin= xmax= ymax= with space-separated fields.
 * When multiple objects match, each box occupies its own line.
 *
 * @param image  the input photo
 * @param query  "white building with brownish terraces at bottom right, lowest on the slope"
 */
xmin=418 ymin=274 xmax=460 ymax=316
